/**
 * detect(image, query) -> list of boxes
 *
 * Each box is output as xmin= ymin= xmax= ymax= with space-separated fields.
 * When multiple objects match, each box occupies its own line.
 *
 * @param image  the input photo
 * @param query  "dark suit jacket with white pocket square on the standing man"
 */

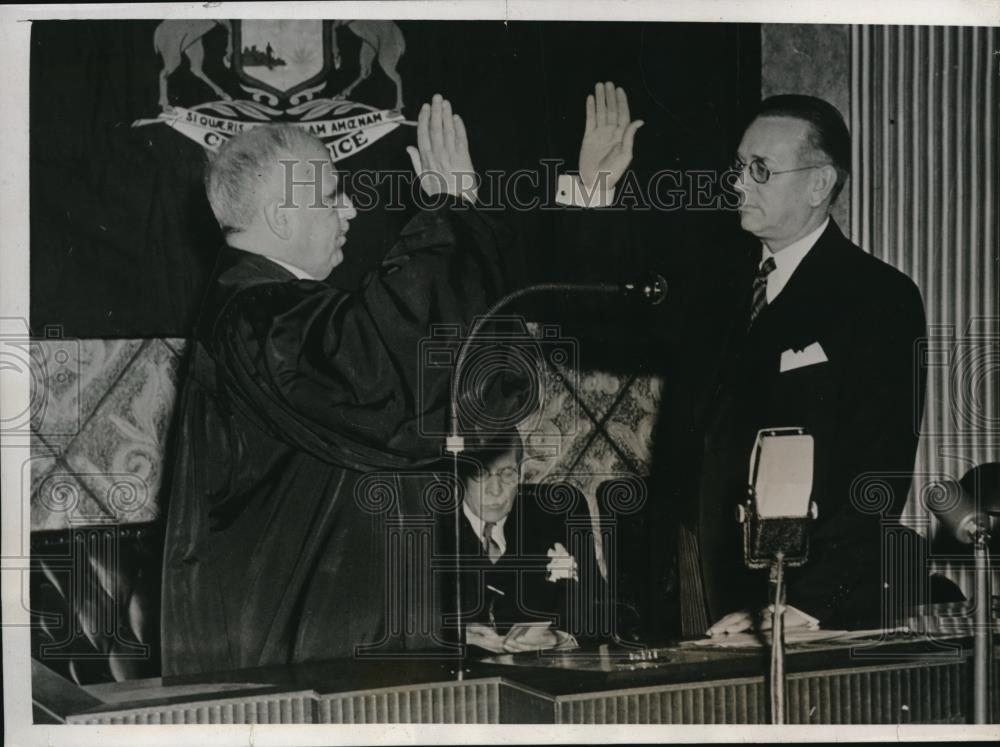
xmin=682 ymin=219 xmax=926 ymax=627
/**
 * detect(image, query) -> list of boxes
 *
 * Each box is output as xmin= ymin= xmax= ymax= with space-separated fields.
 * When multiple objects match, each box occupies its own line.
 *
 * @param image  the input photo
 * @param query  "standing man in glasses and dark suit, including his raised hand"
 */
xmin=560 ymin=84 xmax=926 ymax=636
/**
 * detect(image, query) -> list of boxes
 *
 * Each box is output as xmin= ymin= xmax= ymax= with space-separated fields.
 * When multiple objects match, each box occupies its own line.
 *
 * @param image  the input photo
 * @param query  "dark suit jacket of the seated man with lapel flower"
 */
xmin=444 ymin=485 xmax=610 ymax=641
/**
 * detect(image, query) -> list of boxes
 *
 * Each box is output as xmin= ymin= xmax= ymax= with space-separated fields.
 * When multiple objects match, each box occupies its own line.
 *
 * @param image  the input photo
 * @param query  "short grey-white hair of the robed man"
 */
xmin=205 ymin=124 xmax=326 ymax=233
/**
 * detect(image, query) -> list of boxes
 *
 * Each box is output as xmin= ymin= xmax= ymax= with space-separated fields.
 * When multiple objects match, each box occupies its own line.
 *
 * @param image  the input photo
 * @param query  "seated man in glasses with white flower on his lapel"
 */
xmin=442 ymin=430 xmax=610 ymax=653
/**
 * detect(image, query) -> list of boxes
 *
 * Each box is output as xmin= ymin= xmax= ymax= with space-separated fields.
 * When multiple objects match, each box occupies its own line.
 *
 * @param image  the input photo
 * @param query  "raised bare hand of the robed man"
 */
xmin=406 ymin=93 xmax=478 ymax=203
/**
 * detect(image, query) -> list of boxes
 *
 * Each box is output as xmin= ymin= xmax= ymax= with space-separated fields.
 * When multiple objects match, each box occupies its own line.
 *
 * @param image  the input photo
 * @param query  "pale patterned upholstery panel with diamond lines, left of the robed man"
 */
xmin=30 ymin=339 xmax=183 ymax=531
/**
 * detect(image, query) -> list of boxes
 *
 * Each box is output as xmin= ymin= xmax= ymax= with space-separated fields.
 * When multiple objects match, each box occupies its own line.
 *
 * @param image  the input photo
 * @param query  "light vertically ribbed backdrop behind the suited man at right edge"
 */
xmin=849 ymin=26 xmax=1000 ymax=540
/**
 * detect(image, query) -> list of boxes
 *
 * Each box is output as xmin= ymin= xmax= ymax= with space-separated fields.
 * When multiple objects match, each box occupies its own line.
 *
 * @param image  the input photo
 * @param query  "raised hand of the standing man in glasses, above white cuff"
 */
xmin=580 ymin=81 xmax=643 ymax=189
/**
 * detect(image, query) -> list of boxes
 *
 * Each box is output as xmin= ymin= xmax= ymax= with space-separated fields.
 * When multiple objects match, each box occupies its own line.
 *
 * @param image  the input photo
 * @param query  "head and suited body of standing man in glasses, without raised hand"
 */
xmin=679 ymin=95 xmax=926 ymax=635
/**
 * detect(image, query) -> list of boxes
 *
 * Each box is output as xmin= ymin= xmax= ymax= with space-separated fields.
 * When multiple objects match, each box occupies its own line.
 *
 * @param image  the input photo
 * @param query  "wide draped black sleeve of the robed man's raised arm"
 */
xmin=208 ymin=200 xmax=505 ymax=471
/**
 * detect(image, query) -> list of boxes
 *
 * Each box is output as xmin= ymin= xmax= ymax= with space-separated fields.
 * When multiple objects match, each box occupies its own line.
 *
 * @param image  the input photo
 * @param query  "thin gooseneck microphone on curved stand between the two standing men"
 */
xmin=445 ymin=275 xmax=667 ymax=680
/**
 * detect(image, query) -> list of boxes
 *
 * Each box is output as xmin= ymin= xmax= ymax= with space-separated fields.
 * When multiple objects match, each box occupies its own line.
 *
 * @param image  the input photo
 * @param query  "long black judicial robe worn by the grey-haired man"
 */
xmin=162 ymin=201 xmax=501 ymax=675
